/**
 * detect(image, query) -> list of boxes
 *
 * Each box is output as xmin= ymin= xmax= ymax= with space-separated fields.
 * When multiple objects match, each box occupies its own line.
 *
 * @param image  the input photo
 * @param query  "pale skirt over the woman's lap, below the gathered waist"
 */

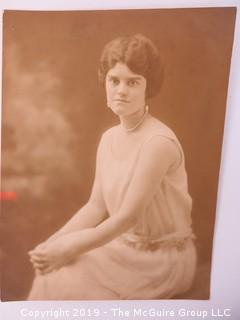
xmin=28 ymin=240 xmax=196 ymax=300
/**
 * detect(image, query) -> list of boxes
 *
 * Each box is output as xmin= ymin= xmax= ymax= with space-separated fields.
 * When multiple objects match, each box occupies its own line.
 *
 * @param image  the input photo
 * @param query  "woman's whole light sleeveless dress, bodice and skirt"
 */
xmin=28 ymin=117 xmax=196 ymax=300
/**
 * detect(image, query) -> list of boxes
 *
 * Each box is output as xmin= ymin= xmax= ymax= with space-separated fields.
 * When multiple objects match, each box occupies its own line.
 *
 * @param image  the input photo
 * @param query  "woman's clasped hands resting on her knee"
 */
xmin=29 ymin=233 xmax=79 ymax=274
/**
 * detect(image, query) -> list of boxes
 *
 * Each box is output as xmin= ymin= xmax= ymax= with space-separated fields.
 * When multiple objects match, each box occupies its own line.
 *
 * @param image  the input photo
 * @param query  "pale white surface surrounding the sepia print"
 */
xmin=0 ymin=0 xmax=240 ymax=320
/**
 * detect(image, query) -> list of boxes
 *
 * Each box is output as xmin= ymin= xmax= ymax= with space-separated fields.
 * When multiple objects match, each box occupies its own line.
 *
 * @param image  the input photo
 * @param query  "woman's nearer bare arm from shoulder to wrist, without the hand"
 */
xmin=67 ymin=136 xmax=181 ymax=253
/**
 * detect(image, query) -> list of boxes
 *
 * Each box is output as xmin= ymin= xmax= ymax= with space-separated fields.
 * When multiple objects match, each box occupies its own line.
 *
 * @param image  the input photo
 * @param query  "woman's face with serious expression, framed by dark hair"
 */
xmin=106 ymin=62 xmax=147 ymax=116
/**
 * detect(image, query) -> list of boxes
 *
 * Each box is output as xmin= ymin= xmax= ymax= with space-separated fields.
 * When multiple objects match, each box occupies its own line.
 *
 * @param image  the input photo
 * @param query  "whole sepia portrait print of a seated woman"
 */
xmin=1 ymin=7 xmax=236 ymax=301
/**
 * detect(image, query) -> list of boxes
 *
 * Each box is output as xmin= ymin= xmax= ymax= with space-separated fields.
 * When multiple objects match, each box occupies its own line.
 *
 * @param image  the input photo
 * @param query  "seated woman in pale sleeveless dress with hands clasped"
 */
xmin=28 ymin=34 xmax=196 ymax=300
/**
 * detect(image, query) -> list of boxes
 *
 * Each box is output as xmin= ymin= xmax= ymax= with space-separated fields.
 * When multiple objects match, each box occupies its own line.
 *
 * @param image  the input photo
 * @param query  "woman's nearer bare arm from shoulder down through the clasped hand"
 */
xmin=31 ymin=136 xmax=181 ymax=273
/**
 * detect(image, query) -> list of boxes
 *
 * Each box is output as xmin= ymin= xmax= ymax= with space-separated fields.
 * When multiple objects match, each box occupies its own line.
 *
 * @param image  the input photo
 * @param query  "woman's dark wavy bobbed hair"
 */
xmin=98 ymin=34 xmax=163 ymax=98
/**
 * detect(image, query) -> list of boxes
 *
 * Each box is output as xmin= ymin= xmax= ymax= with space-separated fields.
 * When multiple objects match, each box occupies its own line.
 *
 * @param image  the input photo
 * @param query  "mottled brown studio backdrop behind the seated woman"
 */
xmin=1 ymin=8 xmax=235 ymax=300
